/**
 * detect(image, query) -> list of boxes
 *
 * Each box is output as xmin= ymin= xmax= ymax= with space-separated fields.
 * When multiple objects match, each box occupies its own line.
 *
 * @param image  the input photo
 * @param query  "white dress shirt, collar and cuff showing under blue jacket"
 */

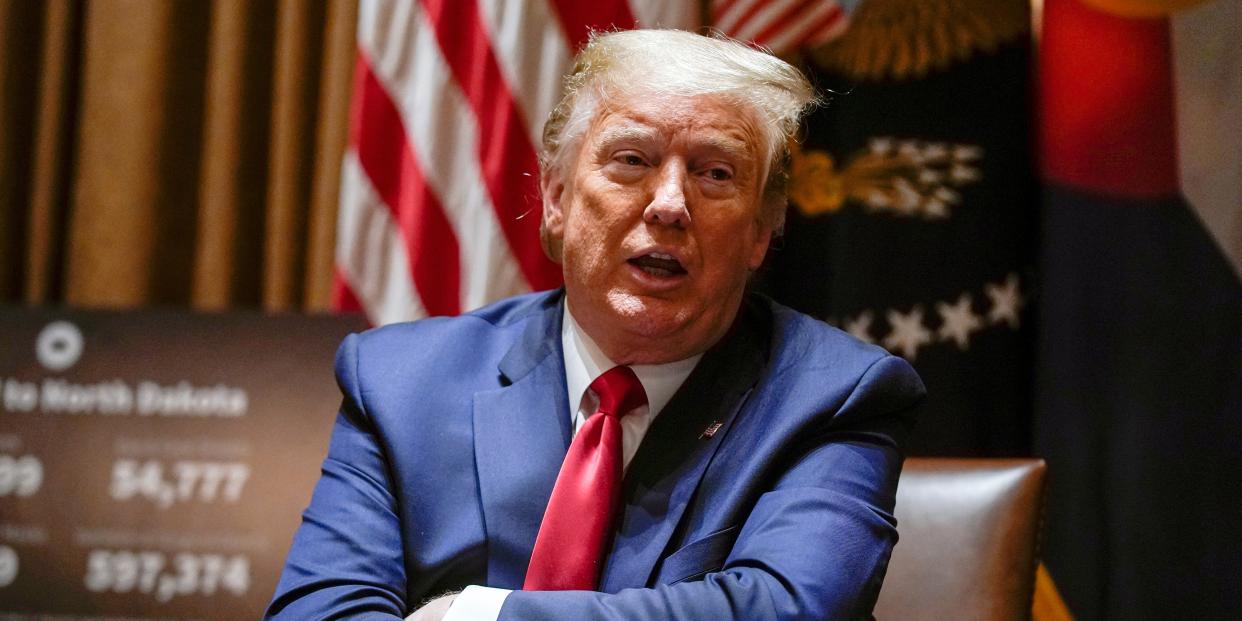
xmin=432 ymin=304 xmax=703 ymax=621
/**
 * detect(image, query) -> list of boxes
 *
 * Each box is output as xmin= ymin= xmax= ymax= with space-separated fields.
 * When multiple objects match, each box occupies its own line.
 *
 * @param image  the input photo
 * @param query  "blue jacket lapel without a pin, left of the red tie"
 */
xmin=473 ymin=297 xmax=571 ymax=589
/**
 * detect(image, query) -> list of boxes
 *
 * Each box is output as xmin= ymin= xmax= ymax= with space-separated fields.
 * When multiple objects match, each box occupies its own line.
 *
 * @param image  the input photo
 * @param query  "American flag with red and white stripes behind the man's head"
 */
xmin=333 ymin=0 xmax=845 ymax=324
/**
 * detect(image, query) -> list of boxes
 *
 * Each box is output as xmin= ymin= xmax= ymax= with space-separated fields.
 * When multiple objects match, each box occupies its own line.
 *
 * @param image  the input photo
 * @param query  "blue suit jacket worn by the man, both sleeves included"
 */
xmin=267 ymin=292 xmax=923 ymax=621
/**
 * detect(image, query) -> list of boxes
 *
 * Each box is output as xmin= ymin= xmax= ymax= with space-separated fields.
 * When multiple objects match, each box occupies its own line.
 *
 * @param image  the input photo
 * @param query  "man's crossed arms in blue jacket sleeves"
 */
xmin=267 ymin=340 xmax=912 ymax=621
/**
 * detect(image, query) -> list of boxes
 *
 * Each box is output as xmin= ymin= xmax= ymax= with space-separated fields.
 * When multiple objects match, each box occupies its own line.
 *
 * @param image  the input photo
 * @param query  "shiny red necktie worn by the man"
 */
xmin=522 ymin=366 xmax=647 ymax=591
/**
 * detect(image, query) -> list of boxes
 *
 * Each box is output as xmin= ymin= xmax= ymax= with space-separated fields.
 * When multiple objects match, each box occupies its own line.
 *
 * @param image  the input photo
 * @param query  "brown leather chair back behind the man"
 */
xmin=876 ymin=458 xmax=1046 ymax=621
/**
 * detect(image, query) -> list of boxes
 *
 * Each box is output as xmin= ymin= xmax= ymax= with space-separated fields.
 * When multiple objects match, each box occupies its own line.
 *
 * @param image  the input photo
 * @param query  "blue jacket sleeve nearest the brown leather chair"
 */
xmin=501 ymin=356 xmax=923 ymax=621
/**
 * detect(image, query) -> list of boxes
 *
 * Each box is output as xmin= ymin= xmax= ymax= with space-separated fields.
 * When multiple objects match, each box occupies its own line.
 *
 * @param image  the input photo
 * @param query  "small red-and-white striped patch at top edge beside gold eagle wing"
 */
xmin=712 ymin=0 xmax=848 ymax=53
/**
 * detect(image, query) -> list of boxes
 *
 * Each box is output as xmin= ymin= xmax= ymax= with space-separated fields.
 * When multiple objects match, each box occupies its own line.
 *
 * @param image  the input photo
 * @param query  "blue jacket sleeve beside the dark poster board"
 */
xmin=265 ymin=335 xmax=406 ymax=621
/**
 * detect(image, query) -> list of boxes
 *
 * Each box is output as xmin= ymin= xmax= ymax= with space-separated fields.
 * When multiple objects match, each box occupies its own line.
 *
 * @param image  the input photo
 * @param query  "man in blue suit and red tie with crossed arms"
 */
xmin=267 ymin=31 xmax=923 ymax=621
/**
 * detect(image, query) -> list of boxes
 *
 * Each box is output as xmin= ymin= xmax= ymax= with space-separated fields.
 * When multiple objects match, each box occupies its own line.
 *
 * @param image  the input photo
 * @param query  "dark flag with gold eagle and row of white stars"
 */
xmin=763 ymin=0 xmax=1036 ymax=456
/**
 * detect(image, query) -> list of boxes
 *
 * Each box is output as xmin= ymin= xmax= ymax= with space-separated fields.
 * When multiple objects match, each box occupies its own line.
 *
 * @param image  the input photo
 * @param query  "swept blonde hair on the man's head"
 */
xmin=539 ymin=30 xmax=818 ymax=232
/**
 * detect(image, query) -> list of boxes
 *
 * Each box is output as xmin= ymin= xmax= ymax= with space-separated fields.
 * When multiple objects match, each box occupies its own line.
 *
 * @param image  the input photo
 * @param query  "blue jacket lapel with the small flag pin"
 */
xmin=600 ymin=300 xmax=766 ymax=592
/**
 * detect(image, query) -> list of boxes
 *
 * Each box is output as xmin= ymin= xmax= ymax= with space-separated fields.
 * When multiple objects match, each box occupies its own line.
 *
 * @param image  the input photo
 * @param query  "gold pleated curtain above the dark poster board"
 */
xmin=0 ymin=0 xmax=356 ymax=311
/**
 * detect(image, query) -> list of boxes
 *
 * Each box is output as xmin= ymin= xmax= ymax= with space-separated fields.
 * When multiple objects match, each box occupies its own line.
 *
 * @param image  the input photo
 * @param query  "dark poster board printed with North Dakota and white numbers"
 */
xmin=0 ymin=308 xmax=364 ymax=621
